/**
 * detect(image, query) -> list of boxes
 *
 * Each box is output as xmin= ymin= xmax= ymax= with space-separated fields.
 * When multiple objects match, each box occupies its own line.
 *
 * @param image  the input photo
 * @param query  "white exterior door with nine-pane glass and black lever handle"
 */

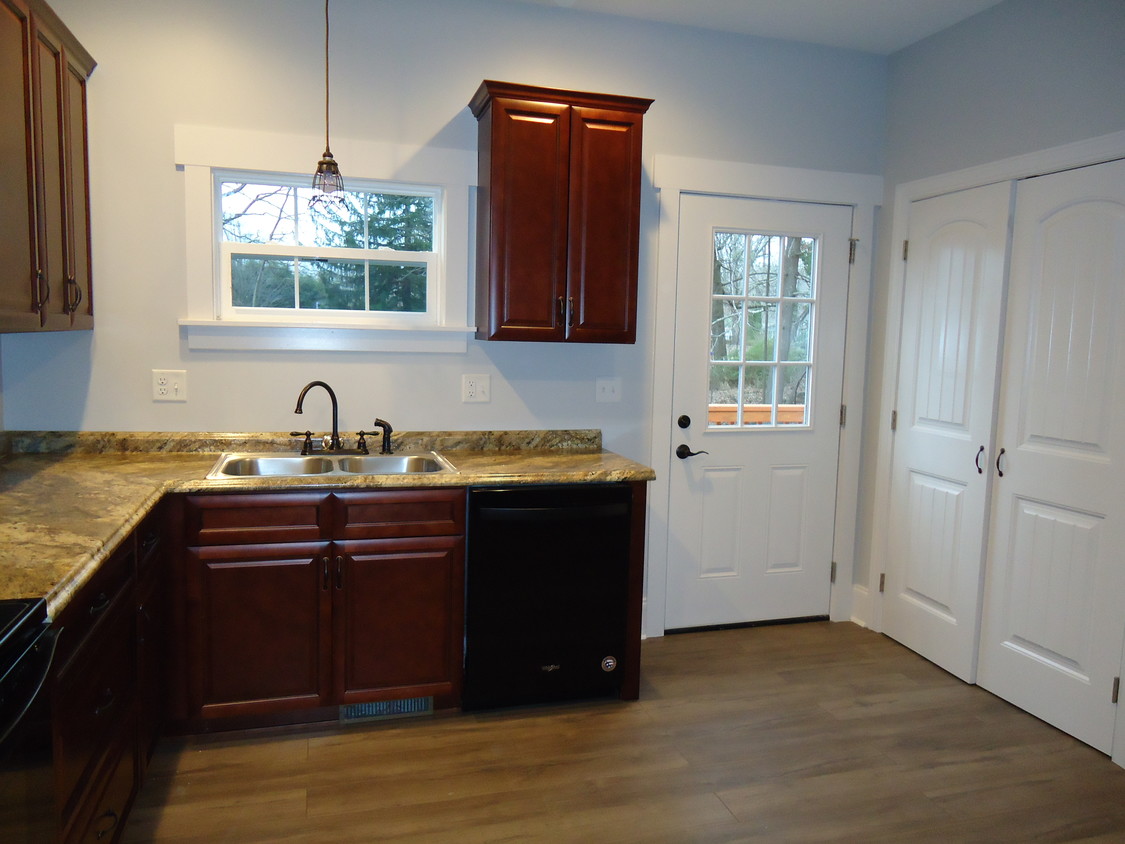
xmin=665 ymin=194 xmax=852 ymax=629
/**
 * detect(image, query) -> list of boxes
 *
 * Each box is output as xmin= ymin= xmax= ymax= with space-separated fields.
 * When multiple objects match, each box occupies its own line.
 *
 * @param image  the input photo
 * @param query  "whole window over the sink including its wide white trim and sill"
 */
xmin=174 ymin=125 xmax=477 ymax=354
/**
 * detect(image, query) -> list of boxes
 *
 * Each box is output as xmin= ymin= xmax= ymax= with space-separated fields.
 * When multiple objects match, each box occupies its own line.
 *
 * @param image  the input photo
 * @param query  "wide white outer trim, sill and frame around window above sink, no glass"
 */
xmin=174 ymin=125 xmax=477 ymax=353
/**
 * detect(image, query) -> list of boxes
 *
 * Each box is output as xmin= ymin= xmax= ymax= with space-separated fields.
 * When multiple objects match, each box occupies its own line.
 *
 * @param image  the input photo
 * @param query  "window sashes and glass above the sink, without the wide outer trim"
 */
xmin=214 ymin=171 xmax=442 ymax=326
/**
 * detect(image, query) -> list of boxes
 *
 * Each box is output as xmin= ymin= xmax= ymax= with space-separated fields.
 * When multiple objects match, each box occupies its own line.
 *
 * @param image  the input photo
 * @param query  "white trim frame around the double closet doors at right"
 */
xmin=852 ymin=132 xmax=1125 ymax=639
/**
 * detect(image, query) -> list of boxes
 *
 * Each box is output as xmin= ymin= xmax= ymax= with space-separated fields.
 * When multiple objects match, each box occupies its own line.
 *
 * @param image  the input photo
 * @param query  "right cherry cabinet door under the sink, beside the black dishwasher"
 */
xmin=334 ymin=537 xmax=465 ymax=703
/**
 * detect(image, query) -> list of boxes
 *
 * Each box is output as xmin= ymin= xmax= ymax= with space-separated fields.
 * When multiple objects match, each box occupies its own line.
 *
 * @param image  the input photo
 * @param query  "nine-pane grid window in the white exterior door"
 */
xmin=708 ymin=231 xmax=817 ymax=428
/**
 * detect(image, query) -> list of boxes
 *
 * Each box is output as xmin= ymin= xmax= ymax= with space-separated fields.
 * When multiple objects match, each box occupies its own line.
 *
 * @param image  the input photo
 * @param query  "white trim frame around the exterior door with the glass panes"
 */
xmin=642 ymin=155 xmax=883 ymax=637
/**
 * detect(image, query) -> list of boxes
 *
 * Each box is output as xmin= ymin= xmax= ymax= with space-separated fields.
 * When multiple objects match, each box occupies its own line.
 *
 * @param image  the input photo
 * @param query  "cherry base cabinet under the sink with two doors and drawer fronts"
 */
xmin=179 ymin=490 xmax=466 ymax=730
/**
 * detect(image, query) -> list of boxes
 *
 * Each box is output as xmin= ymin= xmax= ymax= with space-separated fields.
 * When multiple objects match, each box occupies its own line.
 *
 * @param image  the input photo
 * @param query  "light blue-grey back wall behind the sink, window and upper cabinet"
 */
xmin=0 ymin=0 xmax=887 ymax=459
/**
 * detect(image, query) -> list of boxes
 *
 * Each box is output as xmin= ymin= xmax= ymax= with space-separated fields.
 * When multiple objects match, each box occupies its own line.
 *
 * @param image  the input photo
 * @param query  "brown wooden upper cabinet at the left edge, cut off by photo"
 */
xmin=0 ymin=0 xmax=95 ymax=332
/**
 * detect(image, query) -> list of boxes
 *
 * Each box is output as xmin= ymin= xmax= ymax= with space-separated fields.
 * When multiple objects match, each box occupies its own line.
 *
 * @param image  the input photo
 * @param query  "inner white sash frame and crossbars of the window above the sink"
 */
xmin=212 ymin=168 xmax=444 ymax=329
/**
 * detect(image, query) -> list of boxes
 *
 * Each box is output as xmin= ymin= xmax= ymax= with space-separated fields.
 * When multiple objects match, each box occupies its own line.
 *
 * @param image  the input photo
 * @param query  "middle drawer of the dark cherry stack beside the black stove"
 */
xmin=54 ymin=604 xmax=136 ymax=815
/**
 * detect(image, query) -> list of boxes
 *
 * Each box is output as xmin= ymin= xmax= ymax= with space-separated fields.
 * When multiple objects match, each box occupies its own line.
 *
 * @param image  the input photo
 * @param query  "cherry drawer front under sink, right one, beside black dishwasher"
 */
xmin=335 ymin=488 xmax=466 ymax=539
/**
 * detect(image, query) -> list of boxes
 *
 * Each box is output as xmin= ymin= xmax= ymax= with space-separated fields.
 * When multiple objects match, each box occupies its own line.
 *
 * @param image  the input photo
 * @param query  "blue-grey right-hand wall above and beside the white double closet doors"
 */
xmin=855 ymin=0 xmax=1125 ymax=583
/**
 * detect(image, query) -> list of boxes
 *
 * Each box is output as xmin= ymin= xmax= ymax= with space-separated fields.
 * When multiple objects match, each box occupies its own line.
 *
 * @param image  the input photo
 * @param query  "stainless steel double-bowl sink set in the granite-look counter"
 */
xmin=207 ymin=451 xmax=457 ymax=481
